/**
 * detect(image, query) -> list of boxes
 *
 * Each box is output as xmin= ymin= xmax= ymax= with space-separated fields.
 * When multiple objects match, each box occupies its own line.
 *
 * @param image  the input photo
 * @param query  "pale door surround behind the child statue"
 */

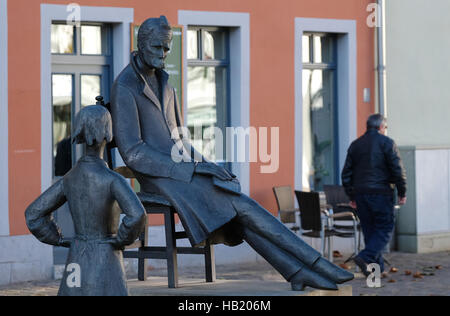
xmin=41 ymin=4 xmax=134 ymax=192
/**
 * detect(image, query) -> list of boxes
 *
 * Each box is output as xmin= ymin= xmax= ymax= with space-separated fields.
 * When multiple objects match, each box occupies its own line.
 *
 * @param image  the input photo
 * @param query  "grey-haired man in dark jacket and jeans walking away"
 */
xmin=342 ymin=114 xmax=406 ymax=275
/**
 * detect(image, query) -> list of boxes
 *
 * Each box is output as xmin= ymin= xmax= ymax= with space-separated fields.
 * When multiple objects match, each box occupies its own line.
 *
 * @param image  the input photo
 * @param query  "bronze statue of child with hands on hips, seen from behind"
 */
xmin=25 ymin=105 xmax=146 ymax=296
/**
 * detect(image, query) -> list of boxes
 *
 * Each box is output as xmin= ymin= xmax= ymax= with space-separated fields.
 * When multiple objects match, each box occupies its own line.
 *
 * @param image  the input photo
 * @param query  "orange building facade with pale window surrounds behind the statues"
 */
xmin=0 ymin=0 xmax=375 ymax=284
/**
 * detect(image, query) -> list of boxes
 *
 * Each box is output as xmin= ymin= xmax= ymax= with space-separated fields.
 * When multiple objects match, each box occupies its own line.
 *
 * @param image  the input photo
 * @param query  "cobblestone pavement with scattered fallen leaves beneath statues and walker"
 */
xmin=0 ymin=252 xmax=450 ymax=296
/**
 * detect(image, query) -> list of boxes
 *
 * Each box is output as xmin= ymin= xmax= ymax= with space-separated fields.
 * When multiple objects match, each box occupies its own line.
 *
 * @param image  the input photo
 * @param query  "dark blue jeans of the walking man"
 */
xmin=355 ymin=194 xmax=395 ymax=272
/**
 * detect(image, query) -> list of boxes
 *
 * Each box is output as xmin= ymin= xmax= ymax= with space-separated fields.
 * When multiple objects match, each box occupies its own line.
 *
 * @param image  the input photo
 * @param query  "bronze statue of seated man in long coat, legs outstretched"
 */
xmin=111 ymin=16 xmax=354 ymax=290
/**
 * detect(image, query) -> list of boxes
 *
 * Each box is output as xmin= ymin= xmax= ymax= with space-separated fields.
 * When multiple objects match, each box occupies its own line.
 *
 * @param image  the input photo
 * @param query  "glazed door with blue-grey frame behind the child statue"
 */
xmin=51 ymin=22 xmax=112 ymax=178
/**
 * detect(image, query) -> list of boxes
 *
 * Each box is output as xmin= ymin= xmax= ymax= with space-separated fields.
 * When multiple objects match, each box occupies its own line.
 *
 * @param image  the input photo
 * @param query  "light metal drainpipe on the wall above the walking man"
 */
xmin=377 ymin=0 xmax=387 ymax=117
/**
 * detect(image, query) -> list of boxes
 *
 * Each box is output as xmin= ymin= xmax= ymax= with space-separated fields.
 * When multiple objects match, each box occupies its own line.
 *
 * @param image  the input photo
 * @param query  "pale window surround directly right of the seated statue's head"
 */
xmin=178 ymin=10 xmax=250 ymax=195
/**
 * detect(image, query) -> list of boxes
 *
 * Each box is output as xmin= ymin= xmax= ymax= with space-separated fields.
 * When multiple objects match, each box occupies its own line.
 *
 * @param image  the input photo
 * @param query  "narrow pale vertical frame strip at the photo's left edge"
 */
xmin=0 ymin=0 xmax=10 ymax=237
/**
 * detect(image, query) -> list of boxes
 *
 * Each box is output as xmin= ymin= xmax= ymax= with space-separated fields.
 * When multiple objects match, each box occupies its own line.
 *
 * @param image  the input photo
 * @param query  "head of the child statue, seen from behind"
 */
xmin=73 ymin=105 xmax=113 ymax=147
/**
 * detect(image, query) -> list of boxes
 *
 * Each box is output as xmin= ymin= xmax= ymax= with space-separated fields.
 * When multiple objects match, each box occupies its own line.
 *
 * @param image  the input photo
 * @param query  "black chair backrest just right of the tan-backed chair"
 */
xmin=295 ymin=191 xmax=322 ymax=231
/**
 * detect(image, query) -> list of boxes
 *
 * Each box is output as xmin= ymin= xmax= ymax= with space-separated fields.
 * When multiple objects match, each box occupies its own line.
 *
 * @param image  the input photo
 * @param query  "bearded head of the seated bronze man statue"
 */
xmin=138 ymin=16 xmax=173 ymax=69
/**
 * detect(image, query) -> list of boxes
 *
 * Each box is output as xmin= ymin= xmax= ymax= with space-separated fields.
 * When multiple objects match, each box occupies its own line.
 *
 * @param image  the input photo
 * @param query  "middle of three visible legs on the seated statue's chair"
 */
xmin=164 ymin=209 xmax=178 ymax=289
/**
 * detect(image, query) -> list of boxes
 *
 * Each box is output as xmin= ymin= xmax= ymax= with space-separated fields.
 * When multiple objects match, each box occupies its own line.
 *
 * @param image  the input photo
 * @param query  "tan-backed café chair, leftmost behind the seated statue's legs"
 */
xmin=273 ymin=186 xmax=301 ymax=234
